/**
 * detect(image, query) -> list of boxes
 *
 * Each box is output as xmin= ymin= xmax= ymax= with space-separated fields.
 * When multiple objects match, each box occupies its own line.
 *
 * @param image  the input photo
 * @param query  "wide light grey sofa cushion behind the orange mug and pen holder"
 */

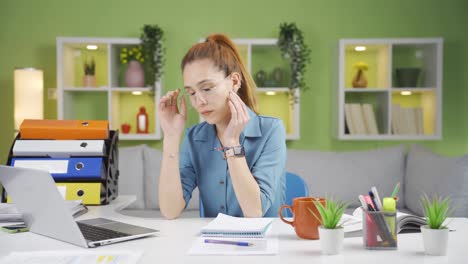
xmin=286 ymin=146 xmax=405 ymax=207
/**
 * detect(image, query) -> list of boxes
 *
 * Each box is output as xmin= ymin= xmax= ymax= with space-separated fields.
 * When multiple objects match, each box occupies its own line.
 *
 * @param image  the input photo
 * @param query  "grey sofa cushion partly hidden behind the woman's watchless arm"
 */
xmin=144 ymin=146 xmax=199 ymax=210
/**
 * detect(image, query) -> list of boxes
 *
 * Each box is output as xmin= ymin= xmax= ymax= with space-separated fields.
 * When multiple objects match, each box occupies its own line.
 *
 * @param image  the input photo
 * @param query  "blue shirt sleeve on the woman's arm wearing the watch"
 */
xmin=252 ymin=119 xmax=286 ymax=216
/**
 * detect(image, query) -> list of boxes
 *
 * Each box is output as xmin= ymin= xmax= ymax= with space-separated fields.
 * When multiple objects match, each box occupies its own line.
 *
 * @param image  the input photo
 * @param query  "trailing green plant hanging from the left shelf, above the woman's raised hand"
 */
xmin=140 ymin=25 xmax=165 ymax=92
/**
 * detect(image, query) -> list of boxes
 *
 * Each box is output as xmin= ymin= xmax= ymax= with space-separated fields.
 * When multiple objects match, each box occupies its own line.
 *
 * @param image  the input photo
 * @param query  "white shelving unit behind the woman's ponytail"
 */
xmin=200 ymin=38 xmax=300 ymax=140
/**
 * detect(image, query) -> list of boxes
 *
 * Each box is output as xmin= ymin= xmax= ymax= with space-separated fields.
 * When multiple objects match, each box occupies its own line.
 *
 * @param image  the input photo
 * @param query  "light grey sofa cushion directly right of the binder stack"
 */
xmin=119 ymin=145 xmax=145 ymax=209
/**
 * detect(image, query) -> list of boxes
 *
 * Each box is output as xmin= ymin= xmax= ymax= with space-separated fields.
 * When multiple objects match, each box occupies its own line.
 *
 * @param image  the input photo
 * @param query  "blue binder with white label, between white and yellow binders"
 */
xmin=11 ymin=157 xmax=106 ymax=181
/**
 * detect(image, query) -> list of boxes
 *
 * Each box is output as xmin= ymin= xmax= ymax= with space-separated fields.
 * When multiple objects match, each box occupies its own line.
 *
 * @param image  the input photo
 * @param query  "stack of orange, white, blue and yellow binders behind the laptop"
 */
xmin=2 ymin=119 xmax=119 ymax=205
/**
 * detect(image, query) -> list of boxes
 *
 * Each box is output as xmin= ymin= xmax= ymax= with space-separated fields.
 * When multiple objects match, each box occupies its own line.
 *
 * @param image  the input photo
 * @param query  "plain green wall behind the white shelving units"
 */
xmin=0 ymin=0 xmax=468 ymax=165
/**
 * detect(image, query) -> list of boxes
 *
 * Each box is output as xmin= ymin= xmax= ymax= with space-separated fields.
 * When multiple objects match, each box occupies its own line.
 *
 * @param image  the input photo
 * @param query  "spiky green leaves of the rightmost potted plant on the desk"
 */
xmin=421 ymin=194 xmax=453 ymax=229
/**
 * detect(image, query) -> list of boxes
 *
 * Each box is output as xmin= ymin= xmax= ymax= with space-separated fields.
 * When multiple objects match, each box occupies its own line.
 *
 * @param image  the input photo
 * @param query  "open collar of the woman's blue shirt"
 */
xmin=194 ymin=107 xmax=262 ymax=142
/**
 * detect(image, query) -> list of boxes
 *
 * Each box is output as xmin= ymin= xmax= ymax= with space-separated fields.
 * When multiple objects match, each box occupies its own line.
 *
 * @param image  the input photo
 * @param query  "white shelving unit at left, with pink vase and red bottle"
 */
xmin=57 ymin=37 xmax=162 ymax=140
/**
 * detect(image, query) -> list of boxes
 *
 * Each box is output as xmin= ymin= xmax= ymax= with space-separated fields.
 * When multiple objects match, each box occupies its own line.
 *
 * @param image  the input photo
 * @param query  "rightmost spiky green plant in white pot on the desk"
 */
xmin=421 ymin=194 xmax=453 ymax=256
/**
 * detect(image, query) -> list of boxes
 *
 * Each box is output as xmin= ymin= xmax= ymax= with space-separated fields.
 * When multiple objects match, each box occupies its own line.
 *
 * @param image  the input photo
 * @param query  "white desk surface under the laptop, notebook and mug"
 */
xmin=0 ymin=196 xmax=468 ymax=264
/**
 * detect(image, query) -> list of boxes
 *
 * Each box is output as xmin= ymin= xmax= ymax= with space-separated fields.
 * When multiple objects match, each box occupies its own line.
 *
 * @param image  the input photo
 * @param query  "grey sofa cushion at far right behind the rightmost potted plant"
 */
xmin=405 ymin=145 xmax=468 ymax=217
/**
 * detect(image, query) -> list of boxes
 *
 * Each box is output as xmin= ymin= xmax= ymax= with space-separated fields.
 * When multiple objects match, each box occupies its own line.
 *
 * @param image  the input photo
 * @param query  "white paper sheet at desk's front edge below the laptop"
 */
xmin=0 ymin=251 xmax=143 ymax=264
